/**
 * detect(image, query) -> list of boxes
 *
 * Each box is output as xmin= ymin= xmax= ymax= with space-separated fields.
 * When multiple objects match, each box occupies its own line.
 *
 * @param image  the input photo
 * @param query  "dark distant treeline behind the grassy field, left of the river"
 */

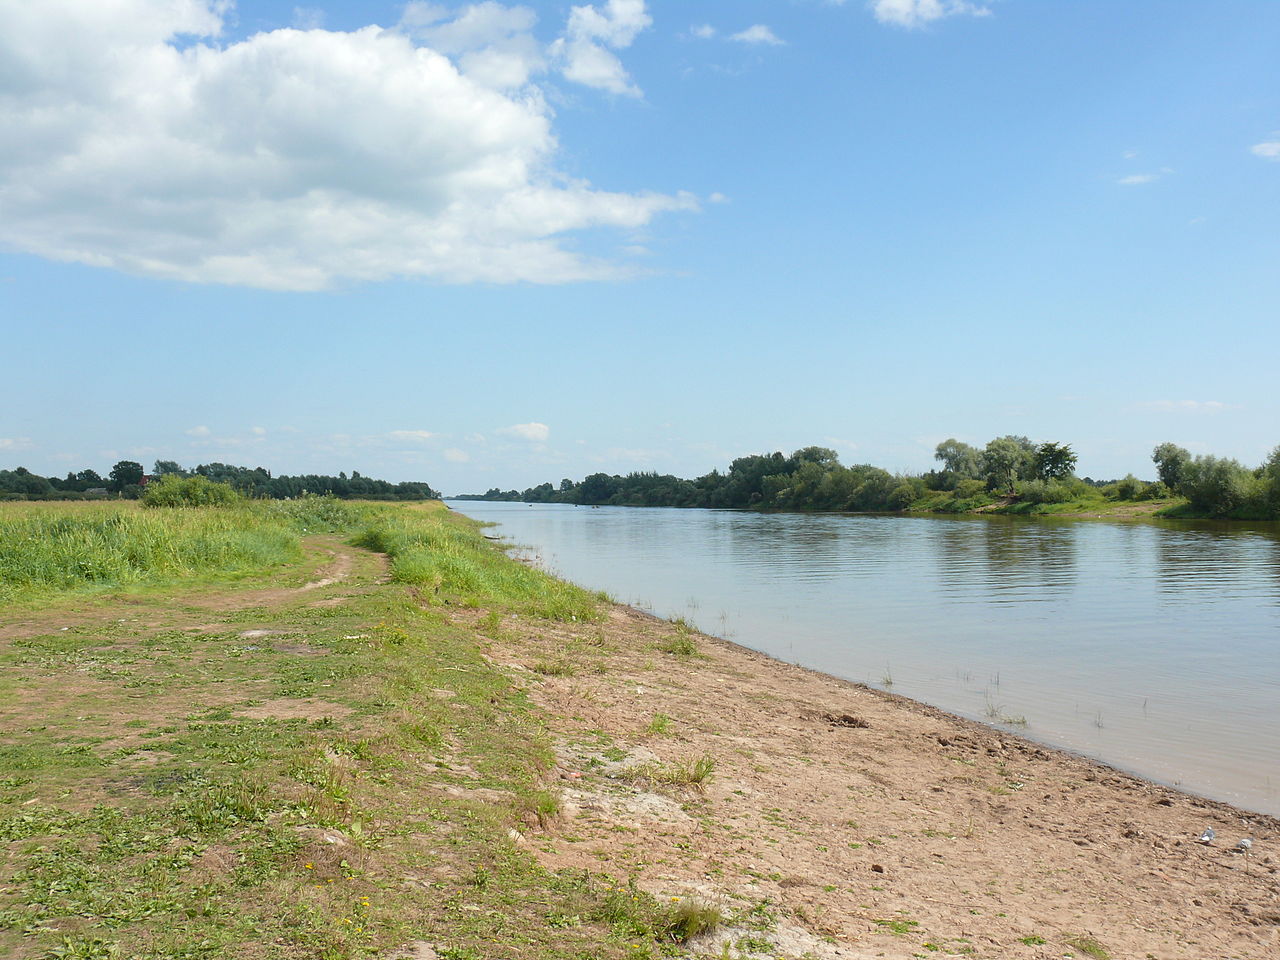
xmin=0 ymin=460 xmax=440 ymax=500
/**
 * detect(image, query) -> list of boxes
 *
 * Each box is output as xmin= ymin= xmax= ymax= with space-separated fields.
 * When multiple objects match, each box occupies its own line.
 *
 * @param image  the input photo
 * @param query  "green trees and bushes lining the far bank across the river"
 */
xmin=458 ymin=435 xmax=1280 ymax=520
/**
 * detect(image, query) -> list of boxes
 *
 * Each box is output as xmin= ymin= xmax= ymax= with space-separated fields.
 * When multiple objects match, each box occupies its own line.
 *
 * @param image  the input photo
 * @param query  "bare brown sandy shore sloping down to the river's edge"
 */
xmin=473 ymin=607 xmax=1280 ymax=960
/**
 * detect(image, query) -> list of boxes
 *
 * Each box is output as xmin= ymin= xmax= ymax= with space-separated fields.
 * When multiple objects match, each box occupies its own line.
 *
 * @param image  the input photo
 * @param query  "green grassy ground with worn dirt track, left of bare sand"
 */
xmin=0 ymin=500 xmax=698 ymax=960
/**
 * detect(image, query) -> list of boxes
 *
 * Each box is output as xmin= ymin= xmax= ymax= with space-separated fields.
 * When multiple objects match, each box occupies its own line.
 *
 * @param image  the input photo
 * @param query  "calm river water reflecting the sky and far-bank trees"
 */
xmin=451 ymin=502 xmax=1280 ymax=814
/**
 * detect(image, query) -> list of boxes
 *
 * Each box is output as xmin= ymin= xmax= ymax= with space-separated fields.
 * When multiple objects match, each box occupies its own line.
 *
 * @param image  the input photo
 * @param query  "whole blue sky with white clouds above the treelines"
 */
xmin=0 ymin=0 xmax=1280 ymax=493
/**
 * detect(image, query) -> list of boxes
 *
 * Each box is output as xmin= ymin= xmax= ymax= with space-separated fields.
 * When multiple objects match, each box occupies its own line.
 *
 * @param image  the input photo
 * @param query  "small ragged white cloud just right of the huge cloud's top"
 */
xmin=550 ymin=0 xmax=653 ymax=97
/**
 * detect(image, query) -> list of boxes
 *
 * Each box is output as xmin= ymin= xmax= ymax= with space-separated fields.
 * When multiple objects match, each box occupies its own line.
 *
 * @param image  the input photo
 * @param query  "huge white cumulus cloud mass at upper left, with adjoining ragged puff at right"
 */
xmin=0 ymin=0 xmax=698 ymax=291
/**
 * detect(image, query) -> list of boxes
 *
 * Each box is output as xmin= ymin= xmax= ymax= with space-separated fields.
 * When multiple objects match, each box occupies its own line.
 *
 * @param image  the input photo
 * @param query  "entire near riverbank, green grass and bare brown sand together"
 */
xmin=0 ymin=504 xmax=1277 ymax=960
